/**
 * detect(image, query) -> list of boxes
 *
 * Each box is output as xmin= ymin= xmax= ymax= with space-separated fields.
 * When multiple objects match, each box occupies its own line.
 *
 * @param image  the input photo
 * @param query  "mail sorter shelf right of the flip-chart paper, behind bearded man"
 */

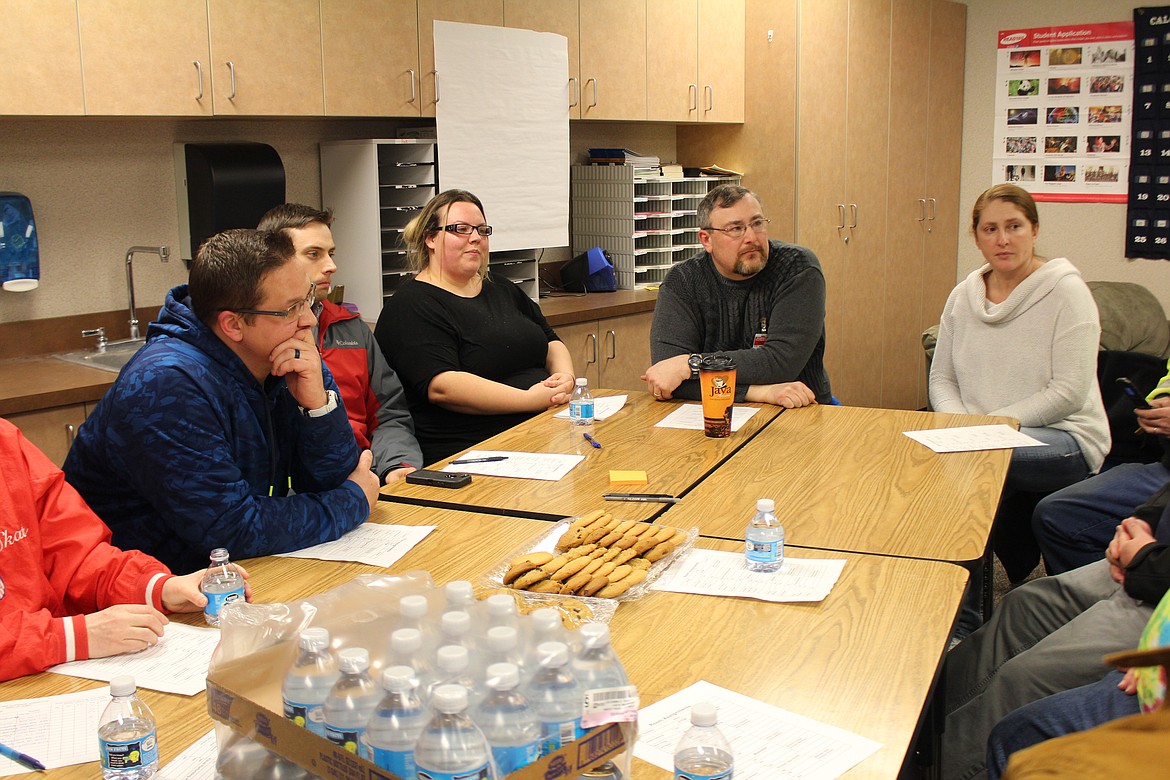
xmin=571 ymin=165 xmax=739 ymax=290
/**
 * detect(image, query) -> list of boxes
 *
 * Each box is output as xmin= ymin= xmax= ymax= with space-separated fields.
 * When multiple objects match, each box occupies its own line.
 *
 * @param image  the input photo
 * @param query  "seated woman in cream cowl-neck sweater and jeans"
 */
xmin=930 ymin=184 xmax=1109 ymax=631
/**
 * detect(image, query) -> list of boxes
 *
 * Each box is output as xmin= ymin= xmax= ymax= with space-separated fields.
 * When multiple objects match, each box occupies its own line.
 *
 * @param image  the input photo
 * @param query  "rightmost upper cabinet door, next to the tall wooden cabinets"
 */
xmin=697 ymin=0 xmax=745 ymax=122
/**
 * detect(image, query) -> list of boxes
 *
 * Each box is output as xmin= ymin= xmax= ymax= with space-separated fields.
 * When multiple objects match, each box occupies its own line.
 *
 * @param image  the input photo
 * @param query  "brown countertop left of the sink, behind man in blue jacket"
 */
xmin=0 ymin=356 xmax=118 ymax=415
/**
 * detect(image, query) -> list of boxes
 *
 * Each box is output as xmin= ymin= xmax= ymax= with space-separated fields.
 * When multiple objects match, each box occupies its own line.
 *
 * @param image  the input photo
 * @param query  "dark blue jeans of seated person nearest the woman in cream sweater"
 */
xmin=1032 ymin=463 xmax=1170 ymax=574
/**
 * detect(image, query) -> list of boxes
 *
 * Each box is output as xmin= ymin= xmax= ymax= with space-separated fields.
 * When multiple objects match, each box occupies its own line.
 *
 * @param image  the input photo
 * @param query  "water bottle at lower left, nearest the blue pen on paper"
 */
xmin=97 ymin=675 xmax=158 ymax=780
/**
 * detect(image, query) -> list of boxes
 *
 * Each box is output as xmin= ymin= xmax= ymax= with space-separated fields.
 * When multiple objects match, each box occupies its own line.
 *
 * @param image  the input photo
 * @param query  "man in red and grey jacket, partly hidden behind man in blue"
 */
xmin=256 ymin=203 xmax=424 ymax=484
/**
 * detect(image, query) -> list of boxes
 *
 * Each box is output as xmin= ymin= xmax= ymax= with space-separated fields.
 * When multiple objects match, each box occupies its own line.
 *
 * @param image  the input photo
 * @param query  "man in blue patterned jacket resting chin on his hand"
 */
xmin=64 ymin=230 xmax=378 ymax=571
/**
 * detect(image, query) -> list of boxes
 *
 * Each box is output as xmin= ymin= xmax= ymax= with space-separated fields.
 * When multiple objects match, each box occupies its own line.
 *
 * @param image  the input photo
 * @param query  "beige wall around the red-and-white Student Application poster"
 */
xmin=957 ymin=0 xmax=1170 ymax=313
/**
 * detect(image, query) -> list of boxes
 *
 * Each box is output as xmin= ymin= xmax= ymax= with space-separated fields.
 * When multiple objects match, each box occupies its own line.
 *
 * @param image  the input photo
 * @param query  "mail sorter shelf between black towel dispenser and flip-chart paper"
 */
xmin=321 ymin=138 xmax=439 ymax=322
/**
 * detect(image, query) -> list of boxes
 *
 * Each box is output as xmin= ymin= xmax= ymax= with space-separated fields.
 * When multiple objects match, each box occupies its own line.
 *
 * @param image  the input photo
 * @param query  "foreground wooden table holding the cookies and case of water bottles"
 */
xmin=0 ymin=503 xmax=966 ymax=780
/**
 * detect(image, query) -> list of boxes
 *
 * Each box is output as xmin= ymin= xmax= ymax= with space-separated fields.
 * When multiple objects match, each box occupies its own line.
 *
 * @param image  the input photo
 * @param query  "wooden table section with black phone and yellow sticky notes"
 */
xmin=381 ymin=391 xmax=780 ymax=520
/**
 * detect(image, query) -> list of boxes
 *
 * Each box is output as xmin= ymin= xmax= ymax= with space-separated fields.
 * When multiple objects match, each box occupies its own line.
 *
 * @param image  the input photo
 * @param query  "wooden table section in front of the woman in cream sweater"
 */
xmin=661 ymin=406 xmax=1016 ymax=561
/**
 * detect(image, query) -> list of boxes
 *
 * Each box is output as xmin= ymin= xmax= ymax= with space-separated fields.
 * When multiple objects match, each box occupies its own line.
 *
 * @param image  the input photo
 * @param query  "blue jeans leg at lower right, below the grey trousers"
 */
xmin=987 ymin=671 xmax=1141 ymax=780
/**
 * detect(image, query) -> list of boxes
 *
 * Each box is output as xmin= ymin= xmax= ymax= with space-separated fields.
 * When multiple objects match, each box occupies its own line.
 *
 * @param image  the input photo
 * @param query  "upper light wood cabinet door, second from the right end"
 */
xmin=646 ymin=0 xmax=697 ymax=122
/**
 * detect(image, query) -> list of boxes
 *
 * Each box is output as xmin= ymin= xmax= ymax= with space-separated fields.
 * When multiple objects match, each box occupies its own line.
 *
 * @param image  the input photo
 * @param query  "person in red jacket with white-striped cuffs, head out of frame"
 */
xmin=0 ymin=419 xmax=250 ymax=681
